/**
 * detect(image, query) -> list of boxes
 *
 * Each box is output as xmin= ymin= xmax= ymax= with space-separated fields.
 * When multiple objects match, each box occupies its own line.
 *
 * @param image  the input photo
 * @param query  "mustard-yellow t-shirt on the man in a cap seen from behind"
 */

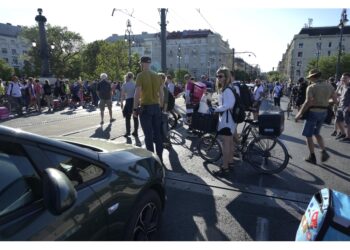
xmin=136 ymin=70 xmax=162 ymax=105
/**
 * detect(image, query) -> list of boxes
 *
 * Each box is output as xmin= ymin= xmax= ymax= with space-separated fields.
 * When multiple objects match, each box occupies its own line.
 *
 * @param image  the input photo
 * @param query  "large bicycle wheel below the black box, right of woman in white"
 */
xmin=244 ymin=136 xmax=289 ymax=174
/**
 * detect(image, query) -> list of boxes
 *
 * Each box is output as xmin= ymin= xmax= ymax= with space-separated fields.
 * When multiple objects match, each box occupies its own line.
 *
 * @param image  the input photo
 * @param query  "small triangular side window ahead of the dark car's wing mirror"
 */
xmin=45 ymin=151 xmax=103 ymax=187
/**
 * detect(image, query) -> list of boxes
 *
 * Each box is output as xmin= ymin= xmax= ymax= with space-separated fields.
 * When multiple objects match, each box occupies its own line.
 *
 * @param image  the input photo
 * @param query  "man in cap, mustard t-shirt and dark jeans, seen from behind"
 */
xmin=133 ymin=56 xmax=164 ymax=163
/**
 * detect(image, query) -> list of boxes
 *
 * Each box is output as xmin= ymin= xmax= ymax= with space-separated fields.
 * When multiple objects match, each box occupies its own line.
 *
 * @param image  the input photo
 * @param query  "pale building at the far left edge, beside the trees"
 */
xmin=0 ymin=23 xmax=28 ymax=69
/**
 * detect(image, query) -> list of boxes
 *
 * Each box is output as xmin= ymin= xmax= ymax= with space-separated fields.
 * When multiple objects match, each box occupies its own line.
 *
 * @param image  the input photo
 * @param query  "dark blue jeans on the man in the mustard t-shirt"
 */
xmin=140 ymin=104 xmax=163 ymax=161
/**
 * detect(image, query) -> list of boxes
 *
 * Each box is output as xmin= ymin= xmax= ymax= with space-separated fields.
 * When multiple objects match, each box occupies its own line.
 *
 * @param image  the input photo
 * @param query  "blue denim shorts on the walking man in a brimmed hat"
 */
xmin=302 ymin=111 xmax=327 ymax=137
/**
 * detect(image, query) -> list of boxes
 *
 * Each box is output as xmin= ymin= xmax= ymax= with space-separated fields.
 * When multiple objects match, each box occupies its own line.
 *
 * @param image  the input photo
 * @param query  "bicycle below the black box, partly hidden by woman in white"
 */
xmin=197 ymin=119 xmax=290 ymax=174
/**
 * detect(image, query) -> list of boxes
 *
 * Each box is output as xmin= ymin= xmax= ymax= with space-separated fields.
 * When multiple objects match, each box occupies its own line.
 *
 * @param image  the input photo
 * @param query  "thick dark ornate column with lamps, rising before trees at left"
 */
xmin=32 ymin=8 xmax=51 ymax=77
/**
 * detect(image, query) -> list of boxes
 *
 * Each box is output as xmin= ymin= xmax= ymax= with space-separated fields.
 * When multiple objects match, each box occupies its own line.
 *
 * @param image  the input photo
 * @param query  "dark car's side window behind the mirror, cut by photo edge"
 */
xmin=0 ymin=142 xmax=42 ymax=217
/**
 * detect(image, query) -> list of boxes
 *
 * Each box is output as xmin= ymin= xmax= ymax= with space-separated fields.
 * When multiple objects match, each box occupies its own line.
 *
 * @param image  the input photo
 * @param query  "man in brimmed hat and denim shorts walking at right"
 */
xmin=295 ymin=69 xmax=336 ymax=164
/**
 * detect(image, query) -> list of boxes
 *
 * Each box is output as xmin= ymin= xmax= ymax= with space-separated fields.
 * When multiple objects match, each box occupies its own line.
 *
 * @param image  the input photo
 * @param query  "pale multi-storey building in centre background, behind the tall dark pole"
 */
xmin=106 ymin=30 xmax=233 ymax=78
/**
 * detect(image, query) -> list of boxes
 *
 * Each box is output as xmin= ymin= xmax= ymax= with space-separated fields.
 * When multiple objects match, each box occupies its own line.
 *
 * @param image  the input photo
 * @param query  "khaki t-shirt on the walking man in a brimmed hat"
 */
xmin=306 ymin=81 xmax=334 ymax=112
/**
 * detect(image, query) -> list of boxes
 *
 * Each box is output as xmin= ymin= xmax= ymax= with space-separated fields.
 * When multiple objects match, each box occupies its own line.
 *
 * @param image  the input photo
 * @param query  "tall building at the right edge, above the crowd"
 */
xmin=278 ymin=26 xmax=350 ymax=82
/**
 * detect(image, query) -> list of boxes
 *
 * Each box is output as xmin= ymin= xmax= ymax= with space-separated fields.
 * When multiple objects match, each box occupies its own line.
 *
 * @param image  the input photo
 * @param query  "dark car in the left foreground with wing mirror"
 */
xmin=0 ymin=125 xmax=166 ymax=241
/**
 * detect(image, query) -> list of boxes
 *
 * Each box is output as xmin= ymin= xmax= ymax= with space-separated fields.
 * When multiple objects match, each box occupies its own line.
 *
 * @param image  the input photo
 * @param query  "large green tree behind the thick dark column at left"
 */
xmin=21 ymin=24 xmax=83 ymax=78
